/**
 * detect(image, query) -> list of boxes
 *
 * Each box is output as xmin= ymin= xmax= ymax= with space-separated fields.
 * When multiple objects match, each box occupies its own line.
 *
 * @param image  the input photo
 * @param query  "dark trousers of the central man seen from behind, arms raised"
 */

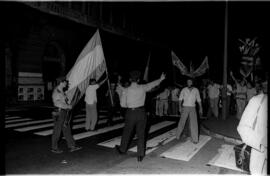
xmin=120 ymin=108 xmax=147 ymax=156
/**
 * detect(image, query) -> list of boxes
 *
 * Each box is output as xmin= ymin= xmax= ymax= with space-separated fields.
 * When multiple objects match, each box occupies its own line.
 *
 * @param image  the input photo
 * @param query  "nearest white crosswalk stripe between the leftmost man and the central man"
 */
xmin=73 ymin=123 xmax=124 ymax=140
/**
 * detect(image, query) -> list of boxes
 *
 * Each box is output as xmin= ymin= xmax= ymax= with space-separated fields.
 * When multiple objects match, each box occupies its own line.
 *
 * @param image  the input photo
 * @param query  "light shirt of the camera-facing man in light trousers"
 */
xmin=179 ymin=87 xmax=201 ymax=107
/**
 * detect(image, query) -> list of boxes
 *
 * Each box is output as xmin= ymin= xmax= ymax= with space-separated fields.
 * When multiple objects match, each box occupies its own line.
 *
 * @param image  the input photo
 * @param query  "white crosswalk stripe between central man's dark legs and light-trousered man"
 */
xmin=129 ymin=128 xmax=176 ymax=155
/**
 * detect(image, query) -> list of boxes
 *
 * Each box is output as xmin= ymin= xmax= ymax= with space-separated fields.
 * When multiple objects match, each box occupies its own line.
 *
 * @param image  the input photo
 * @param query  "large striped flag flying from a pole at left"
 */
xmin=66 ymin=30 xmax=107 ymax=106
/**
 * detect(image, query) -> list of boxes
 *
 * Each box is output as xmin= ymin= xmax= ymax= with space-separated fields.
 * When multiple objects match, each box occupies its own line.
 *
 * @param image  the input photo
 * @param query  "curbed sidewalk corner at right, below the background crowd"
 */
xmin=201 ymin=116 xmax=242 ymax=145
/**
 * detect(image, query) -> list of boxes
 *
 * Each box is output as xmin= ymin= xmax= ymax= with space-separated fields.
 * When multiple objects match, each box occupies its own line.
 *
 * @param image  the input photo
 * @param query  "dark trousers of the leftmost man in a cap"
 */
xmin=52 ymin=109 xmax=75 ymax=149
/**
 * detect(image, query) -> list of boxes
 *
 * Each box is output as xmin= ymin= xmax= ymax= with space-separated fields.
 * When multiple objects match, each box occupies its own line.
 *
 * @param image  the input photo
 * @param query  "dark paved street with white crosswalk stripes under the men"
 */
xmin=5 ymin=108 xmax=245 ymax=174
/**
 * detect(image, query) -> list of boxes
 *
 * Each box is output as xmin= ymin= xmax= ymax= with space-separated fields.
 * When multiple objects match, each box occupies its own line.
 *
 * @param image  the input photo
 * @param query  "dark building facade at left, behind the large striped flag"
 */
xmin=1 ymin=2 xmax=156 ymax=104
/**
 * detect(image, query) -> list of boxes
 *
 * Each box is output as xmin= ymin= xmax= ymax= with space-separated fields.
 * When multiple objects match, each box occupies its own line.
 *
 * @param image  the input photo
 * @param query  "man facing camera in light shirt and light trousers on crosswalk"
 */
xmin=176 ymin=78 xmax=202 ymax=144
